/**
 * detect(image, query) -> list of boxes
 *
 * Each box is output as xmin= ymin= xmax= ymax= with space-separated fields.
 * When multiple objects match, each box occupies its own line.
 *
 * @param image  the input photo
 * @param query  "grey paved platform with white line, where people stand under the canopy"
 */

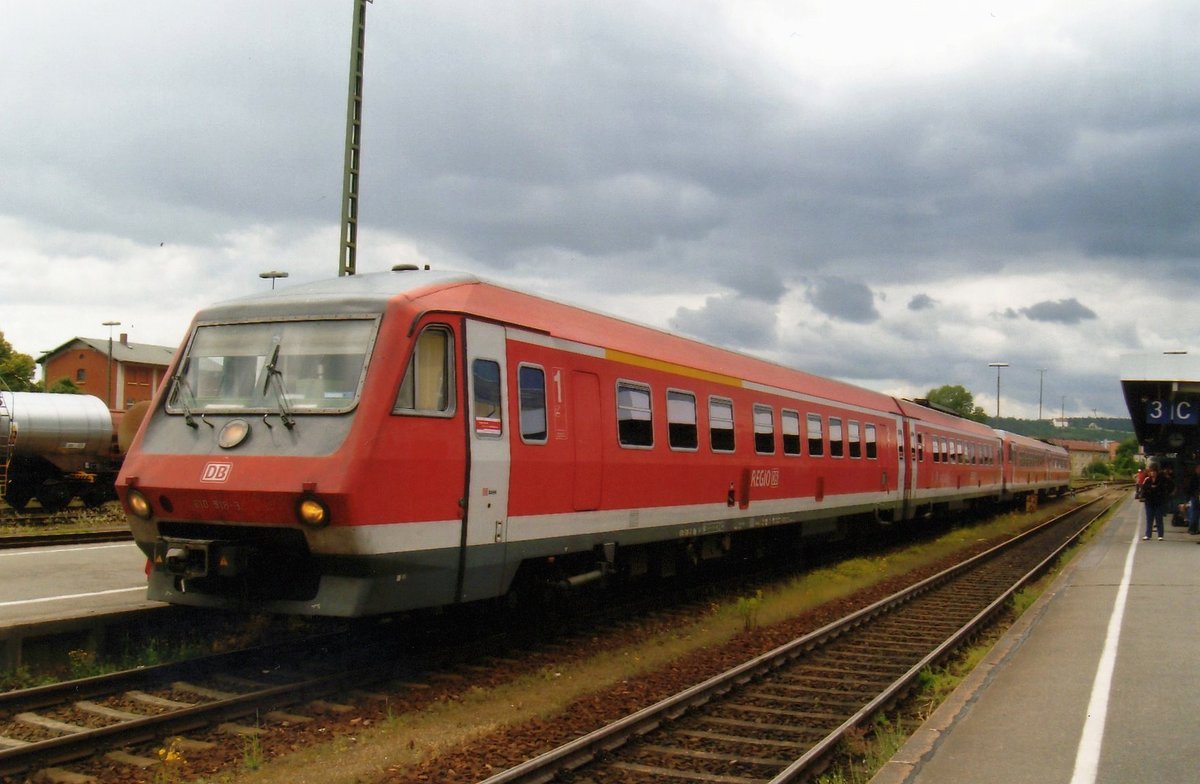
xmin=871 ymin=493 xmax=1200 ymax=784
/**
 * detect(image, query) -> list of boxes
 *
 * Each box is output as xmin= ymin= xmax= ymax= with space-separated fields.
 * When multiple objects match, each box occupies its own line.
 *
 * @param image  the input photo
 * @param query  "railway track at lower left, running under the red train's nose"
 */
xmin=0 ymin=632 xmax=410 ymax=782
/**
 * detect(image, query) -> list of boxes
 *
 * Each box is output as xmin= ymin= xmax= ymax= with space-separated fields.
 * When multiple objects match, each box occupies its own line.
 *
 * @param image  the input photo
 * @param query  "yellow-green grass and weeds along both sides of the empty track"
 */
xmin=196 ymin=492 xmax=1104 ymax=784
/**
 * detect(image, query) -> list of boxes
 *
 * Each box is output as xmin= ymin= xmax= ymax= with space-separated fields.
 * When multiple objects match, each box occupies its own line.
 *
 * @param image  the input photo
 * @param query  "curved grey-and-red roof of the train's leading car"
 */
xmin=197 ymin=268 xmax=902 ymax=415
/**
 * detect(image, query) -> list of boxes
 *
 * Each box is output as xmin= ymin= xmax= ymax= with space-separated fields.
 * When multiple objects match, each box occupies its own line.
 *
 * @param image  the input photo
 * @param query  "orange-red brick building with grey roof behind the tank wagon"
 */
xmin=37 ymin=333 xmax=175 ymax=411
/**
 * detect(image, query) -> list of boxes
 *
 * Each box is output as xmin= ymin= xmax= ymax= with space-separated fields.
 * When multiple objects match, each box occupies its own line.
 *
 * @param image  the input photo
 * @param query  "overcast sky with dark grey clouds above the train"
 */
xmin=0 ymin=0 xmax=1200 ymax=417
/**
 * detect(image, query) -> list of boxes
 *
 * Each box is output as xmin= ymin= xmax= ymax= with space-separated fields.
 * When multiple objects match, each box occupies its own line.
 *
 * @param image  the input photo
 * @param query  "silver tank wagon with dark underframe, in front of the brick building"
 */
xmin=0 ymin=391 xmax=120 ymax=511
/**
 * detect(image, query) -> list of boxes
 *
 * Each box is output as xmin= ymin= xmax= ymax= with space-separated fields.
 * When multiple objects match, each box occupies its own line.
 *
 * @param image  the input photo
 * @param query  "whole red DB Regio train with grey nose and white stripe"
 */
xmin=118 ymin=268 xmax=1067 ymax=616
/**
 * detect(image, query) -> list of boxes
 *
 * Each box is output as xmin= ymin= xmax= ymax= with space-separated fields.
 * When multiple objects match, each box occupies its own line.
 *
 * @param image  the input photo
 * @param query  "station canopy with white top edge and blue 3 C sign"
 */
xmin=1121 ymin=352 xmax=1200 ymax=457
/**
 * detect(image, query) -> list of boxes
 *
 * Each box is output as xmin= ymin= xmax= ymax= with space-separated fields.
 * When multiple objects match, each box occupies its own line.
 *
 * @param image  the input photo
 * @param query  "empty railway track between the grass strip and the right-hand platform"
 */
xmin=484 ymin=492 xmax=1110 ymax=784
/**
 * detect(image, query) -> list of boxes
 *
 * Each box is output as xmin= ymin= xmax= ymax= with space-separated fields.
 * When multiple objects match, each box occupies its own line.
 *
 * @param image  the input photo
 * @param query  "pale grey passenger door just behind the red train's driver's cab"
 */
xmin=458 ymin=319 xmax=509 ymax=602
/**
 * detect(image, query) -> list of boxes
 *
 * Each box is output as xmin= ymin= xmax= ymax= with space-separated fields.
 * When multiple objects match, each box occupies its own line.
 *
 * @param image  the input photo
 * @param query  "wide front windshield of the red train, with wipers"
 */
xmin=167 ymin=319 xmax=376 ymax=414
